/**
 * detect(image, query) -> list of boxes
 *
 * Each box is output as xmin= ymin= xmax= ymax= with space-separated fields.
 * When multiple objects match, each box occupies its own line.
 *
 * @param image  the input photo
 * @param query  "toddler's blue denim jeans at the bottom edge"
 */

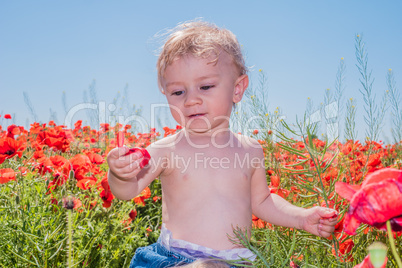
xmin=129 ymin=243 xmax=194 ymax=268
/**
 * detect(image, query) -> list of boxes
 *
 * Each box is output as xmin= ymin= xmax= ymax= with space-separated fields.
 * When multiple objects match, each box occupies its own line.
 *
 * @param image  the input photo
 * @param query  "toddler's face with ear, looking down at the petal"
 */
xmin=162 ymin=52 xmax=248 ymax=132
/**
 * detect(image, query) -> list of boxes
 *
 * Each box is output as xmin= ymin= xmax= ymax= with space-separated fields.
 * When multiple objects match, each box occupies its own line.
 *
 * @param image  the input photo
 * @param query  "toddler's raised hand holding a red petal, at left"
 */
xmin=107 ymin=146 xmax=144 ymax=181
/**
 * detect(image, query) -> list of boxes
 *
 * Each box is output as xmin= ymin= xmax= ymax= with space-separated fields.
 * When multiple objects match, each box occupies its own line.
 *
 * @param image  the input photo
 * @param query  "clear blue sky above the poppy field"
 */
xmin=0 ymin=0 xmax=402 ymax=142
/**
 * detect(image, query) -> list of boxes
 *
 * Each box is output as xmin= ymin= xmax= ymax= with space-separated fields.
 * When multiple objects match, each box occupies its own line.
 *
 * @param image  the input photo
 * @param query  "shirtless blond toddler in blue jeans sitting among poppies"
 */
xmin=107 ymin=21 xmax=337 ymax=267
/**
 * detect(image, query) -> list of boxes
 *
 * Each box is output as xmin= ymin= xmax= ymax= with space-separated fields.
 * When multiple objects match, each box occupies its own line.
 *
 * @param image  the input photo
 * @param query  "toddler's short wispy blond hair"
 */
xmin=156 ymin=20 xmax=247 ymax=90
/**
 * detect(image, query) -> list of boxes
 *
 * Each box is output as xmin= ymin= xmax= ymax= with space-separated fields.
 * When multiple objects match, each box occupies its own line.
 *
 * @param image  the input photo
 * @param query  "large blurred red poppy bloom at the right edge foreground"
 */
xmin=335 ymin=168 xmax=402 ymax=235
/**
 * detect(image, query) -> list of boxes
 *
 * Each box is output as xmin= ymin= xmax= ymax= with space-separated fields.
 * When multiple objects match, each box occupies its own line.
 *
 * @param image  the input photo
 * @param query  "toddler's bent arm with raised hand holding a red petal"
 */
xmin=108 ymin=144 xmax=167 ymax=200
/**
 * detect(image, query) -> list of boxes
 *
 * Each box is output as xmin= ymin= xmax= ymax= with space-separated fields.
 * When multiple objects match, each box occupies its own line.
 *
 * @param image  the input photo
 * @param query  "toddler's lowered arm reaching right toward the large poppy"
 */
xmin=251 ymin=144 xmax=337 ymax=237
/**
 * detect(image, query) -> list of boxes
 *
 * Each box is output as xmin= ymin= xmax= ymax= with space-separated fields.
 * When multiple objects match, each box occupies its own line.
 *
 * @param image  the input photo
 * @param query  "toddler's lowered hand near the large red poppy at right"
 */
xmin=302 ymin=207 xmax=338 ymax=237
